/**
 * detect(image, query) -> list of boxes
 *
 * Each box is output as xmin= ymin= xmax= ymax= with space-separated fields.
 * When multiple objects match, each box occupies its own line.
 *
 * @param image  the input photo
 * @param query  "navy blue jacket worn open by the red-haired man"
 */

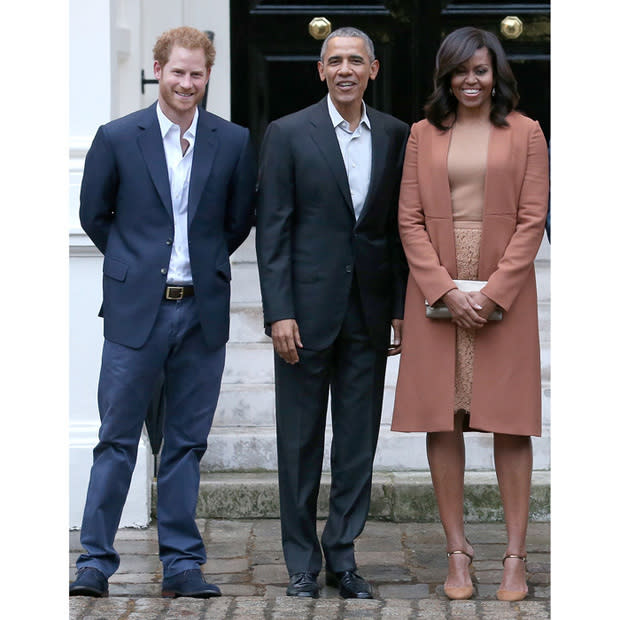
xmin=80 ymin=104 xmax=256 ymax=350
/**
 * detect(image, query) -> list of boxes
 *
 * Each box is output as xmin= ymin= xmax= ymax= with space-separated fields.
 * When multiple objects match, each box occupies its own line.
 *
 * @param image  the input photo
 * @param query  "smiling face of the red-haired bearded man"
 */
xmin=153 ymin=45 xmax=211 ymax=129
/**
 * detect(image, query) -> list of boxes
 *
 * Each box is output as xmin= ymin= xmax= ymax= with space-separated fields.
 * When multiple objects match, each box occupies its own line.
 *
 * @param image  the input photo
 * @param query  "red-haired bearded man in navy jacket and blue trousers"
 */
xmin=70 ymin=27 xmax=256 ymax=597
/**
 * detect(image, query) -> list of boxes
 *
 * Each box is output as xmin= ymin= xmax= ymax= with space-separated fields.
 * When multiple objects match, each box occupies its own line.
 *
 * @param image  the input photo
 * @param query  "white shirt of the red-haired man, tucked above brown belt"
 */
xmin=157 ymin=102 xmax=198 ymax=284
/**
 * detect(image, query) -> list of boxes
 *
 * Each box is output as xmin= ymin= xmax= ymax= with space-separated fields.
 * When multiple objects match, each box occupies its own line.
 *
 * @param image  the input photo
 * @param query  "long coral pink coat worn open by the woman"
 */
xmin=392 ymin=112 xmax=549 ymax=436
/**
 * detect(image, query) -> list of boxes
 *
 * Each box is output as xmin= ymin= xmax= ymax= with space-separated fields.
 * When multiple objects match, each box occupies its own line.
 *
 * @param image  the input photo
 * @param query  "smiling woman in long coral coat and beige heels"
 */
xmin=392 ymin=28 xmax=549 ymax=600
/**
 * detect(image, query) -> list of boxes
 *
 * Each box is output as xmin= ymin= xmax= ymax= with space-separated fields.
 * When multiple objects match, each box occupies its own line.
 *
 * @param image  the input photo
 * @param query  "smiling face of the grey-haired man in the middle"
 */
xmin=318 ymin=36 xmax=379 ymax=120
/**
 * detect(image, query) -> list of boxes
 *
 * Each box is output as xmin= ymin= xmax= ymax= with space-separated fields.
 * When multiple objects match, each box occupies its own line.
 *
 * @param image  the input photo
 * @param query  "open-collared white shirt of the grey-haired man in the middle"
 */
xmin=327 ymin=95 xmax=372 ymax=219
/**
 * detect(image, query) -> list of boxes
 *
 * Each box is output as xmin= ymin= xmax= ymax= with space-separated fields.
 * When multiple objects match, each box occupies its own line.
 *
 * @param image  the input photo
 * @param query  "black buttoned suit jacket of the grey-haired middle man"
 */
xmin=256 ymin=98 xmax=409 ymax=350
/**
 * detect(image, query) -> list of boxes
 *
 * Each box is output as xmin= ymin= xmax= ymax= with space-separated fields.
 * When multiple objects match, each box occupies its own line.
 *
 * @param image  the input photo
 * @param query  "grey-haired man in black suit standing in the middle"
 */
xmin=256 ymin=28 xmax=408 ymax=598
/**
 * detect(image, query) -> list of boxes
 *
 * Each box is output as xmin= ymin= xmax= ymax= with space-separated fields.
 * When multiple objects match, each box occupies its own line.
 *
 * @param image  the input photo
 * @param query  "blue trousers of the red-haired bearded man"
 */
xmin=76 ymin=297 xmax=225 ymax=577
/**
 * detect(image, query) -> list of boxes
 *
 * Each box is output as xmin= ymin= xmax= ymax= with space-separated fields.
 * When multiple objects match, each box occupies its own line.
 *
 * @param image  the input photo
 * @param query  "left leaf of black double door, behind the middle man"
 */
xmin=231 ymin=0 xmax=412 ymax=144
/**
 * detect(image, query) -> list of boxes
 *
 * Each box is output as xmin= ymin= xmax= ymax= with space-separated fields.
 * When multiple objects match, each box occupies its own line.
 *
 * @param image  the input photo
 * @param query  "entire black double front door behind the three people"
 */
xmin=230 ymin=0 xmax=549 ymax=146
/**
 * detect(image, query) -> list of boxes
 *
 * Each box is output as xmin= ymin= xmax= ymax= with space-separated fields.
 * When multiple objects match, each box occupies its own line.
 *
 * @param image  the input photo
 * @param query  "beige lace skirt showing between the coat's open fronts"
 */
xmin=454 ymin=222 xmax=482 ymax=412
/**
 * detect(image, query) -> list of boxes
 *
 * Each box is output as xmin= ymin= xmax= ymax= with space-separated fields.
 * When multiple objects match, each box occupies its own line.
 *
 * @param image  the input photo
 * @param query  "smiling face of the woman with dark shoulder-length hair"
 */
xmin=450 ymin=47 xmax=494 ymax=114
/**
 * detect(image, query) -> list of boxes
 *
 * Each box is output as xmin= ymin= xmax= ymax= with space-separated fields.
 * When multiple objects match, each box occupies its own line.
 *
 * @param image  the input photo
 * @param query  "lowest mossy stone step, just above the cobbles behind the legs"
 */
xmin=152 ymin=472 xmax=550 ymax=523
